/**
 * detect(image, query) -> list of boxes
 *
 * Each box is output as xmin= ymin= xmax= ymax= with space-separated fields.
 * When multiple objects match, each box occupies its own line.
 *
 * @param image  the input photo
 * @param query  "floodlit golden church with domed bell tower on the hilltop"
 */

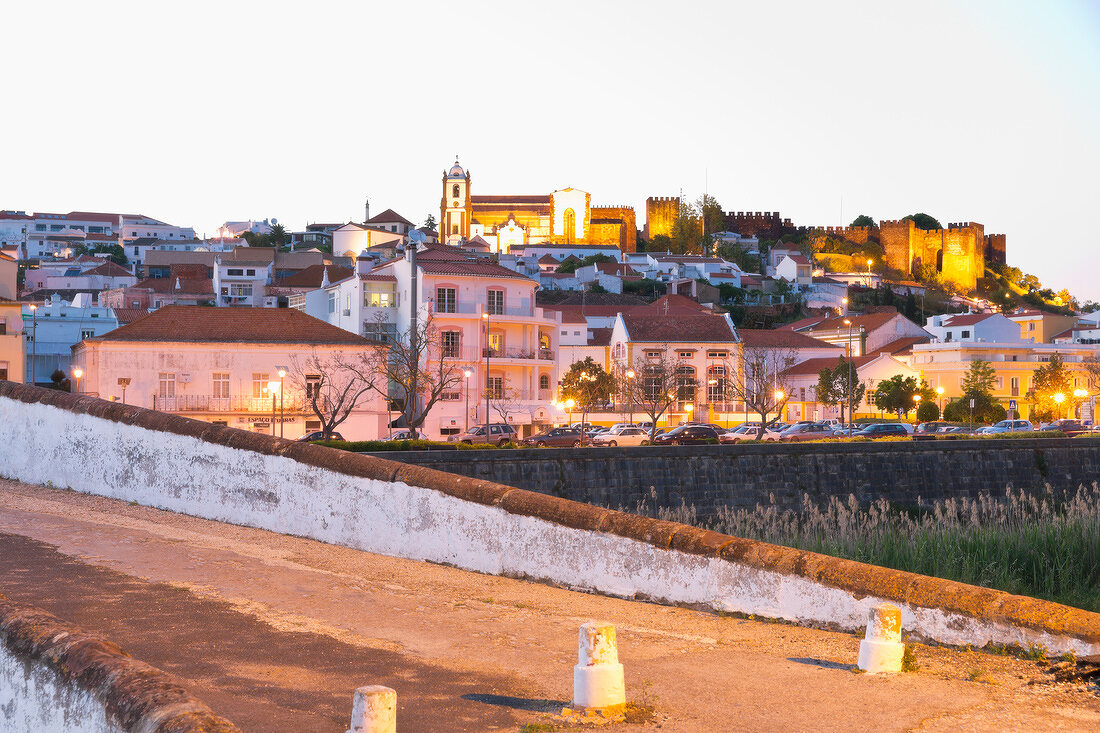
xmin=439 ymin=161 xmax=638 ymax=254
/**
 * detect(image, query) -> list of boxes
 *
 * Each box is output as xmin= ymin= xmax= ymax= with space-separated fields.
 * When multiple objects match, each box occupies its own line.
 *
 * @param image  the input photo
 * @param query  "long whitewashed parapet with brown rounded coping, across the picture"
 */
xmin=0 ymin=381 xmax=1100 ymax=655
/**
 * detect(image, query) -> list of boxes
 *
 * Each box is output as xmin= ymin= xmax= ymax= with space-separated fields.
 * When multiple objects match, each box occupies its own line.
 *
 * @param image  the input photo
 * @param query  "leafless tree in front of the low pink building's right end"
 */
xmin=292 ymin=351 xmax=378 ymax=440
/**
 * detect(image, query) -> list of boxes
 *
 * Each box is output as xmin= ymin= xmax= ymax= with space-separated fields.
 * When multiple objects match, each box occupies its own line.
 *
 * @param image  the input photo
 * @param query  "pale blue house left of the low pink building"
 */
xmin=23 ymin=293 xmax=119 ymax=384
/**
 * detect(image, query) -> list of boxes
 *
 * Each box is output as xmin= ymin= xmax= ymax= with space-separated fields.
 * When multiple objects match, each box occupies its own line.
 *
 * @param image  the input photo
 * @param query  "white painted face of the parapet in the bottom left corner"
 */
xmin=0 ymin=644 xmax=124 ymax=733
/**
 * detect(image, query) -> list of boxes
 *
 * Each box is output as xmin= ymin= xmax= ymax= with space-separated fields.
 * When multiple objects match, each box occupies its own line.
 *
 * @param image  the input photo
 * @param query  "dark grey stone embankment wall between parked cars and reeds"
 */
xmin=369 ymin=438 xmax=1100 ymax=517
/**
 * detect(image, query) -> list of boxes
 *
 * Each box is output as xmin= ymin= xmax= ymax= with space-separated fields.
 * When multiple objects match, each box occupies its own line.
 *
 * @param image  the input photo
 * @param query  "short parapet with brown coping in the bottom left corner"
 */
xmin=0 ymin=595 xmax=240 ymax=733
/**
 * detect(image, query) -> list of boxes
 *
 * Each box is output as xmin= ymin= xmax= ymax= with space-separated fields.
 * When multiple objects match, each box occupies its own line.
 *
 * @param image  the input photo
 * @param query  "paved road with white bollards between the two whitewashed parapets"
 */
xmin=0 ymin=480 xmax=1100 ymax=731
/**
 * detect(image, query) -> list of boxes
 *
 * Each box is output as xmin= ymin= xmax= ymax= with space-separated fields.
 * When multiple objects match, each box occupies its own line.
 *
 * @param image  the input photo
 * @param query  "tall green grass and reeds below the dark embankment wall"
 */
xmin=635 ymin=483 xmax=1100 ymax=612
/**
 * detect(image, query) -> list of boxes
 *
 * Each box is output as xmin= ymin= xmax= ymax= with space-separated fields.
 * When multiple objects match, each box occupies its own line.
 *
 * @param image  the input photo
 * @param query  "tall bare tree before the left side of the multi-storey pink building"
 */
xmin=374 ymin=314 xmax=462 ymax=437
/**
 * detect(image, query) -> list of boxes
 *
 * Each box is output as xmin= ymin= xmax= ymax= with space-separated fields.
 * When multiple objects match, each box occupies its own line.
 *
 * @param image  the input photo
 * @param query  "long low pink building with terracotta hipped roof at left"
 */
xmin=73 ymin=306 xmax=388 ymax=440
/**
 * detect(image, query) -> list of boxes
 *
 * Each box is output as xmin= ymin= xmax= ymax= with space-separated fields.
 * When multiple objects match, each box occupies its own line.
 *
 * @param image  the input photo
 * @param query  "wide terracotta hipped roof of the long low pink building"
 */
xmin=87 ymin=306 xmax=372 ymax=346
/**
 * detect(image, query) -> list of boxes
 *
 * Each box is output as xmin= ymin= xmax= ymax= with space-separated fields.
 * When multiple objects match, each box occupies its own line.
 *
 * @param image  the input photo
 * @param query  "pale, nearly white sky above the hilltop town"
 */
xmin=8 ymin=0 xmax=1100 ymax=300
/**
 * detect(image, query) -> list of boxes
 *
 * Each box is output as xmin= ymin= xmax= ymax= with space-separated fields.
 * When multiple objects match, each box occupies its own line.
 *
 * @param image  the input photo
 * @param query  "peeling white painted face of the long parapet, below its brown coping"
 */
xmin=0 ymin=396 xmax=1100 ymax=655
